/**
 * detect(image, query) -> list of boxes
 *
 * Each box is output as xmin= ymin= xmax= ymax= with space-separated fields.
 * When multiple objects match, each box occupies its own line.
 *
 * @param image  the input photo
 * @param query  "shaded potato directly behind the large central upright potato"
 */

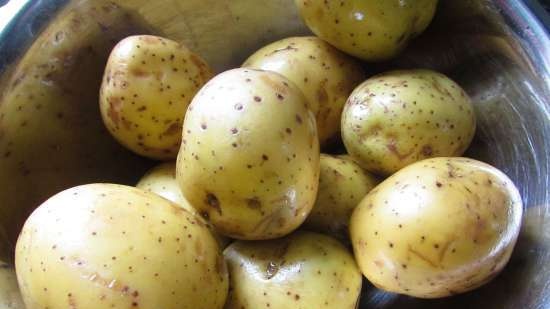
xmin=243 ymin=36 xmax=365 ymax=145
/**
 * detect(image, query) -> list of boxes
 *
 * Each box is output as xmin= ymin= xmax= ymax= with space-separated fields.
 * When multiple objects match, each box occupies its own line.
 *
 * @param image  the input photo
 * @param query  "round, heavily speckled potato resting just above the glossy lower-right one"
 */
xmin=342 ymin=70 xmax=476 ymax=175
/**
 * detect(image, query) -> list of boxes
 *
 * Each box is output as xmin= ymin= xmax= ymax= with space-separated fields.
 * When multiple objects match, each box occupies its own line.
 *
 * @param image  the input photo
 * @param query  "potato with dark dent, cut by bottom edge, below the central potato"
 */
xmin=224 ymin=232 xmax=362 ymax=309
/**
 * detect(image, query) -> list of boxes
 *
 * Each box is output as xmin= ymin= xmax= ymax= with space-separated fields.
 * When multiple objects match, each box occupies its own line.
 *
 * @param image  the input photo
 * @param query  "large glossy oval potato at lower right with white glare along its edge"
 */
xmin=350 ymin=157 xmax=522 ymax=298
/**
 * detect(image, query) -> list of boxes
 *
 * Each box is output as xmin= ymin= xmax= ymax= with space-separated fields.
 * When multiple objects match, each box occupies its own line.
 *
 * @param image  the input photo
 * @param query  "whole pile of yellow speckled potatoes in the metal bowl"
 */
xmin=5 ymin=0 xmax=522 ymax=309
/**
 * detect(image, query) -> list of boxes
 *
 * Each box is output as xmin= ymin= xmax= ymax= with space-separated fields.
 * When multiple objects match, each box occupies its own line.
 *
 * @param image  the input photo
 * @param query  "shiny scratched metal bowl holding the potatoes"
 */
xmin=0 ymin=0 xmax=550 ymax=309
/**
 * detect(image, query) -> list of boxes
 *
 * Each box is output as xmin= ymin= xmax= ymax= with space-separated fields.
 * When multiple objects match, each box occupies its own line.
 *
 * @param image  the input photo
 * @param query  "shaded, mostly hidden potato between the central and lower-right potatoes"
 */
xmin=304 ymin=154 xmax=379 ymax=240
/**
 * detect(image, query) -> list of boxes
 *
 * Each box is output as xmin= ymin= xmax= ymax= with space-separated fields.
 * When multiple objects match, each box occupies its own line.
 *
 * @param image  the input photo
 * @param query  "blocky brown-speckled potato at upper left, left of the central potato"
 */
xmin=100 ymin=35 xmax=213 ymax=160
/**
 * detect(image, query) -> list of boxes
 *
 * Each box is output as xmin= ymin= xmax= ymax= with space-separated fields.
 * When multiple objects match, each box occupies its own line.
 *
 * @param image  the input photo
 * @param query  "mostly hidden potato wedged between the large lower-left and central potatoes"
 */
xmin=136 ymin=162 xmax=234 ymax=248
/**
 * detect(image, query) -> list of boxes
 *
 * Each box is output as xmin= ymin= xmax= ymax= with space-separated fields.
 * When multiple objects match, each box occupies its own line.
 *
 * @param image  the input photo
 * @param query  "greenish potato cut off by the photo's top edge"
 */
xmin=295 ymin=0 xmax=437 ymax=61
